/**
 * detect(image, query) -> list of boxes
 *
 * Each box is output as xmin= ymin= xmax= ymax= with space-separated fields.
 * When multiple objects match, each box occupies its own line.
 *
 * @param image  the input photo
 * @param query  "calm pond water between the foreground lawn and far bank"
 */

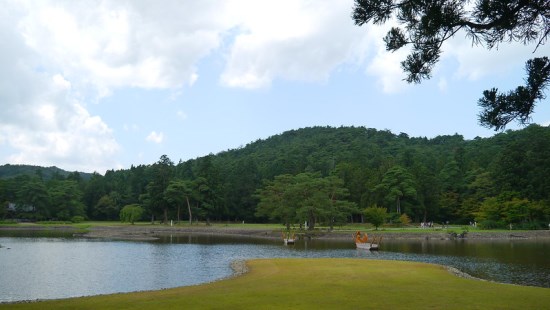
xmin=0 ymin=232 xmax=550 ymax=302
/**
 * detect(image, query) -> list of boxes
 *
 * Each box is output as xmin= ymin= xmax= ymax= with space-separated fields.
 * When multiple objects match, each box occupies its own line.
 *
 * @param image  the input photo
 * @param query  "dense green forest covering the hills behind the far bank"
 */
xmin=0 ymin=125 xmax=550 ymax=229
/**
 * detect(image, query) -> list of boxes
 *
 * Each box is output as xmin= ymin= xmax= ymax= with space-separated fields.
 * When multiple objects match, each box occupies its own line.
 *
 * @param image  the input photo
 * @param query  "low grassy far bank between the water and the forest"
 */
xmin=0 ymin=222 xmax=550 ymax=241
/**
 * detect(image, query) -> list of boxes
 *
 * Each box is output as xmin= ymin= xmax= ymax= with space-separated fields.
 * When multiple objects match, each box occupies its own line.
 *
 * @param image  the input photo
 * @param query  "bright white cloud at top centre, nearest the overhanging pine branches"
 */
xmin=221 ymin=0 xmax=374 ymax=88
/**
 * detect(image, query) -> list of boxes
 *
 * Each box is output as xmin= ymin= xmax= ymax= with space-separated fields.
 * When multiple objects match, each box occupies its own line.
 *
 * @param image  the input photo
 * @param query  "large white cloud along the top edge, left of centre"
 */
xmin=18 ymin=1 xmax=231 ymax=96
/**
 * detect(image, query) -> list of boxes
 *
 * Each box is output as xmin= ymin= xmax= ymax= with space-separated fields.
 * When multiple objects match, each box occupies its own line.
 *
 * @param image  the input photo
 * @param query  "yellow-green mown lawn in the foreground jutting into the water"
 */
xmin=0 ymin=259 xmax=550 ymax=309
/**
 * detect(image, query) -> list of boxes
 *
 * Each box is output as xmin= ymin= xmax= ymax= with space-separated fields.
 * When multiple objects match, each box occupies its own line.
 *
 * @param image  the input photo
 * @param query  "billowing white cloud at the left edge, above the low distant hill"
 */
xmin=0 ymin=7 xmax=119 ymax=172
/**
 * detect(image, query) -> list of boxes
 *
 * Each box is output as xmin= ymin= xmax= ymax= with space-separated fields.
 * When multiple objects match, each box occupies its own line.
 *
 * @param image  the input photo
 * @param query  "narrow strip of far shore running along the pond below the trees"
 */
xmin=0 ymin=224 xmax=550 ymax=241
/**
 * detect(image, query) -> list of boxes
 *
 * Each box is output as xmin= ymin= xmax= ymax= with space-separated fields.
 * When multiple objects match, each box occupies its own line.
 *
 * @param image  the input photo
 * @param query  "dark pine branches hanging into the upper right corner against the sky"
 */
xmin=352 ymin=0 xmax=550 ymax=130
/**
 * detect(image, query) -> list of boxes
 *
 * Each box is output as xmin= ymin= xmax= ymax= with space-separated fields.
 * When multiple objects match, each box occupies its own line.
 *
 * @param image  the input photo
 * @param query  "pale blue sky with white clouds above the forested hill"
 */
xmin=0 ymin=0 xmax=550 ymax=174
